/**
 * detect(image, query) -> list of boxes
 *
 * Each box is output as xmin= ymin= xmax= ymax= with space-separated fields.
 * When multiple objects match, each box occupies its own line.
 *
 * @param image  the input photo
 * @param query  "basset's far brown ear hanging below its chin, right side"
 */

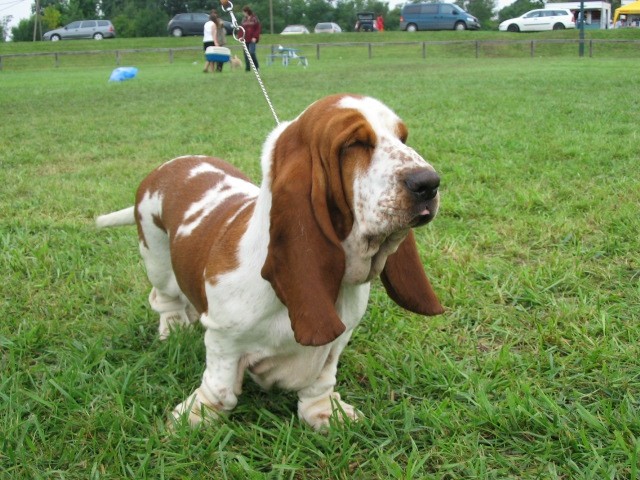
xmin=380 ymin=231 xmax=444 ymax=315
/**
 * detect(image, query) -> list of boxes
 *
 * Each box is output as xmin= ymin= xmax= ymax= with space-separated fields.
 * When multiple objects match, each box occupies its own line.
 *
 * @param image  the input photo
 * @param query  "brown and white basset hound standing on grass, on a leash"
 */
xmin=97 ymin=94 xmax=443 ymax=429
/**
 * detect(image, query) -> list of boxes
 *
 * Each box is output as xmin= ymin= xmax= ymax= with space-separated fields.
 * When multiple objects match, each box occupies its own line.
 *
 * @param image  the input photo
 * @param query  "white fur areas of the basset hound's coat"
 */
xmin=99 ymin=97 xmax=436 ymax=428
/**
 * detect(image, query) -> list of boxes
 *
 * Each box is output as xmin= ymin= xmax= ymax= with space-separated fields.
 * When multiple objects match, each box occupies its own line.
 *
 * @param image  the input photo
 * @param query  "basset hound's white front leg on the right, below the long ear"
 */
xmin=298 ymin=332 xmax=362 ymax=430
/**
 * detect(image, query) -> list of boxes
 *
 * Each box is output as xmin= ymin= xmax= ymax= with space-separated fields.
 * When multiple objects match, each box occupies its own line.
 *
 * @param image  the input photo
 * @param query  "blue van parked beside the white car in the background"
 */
xmin=400 ymin=3 xmax=480 ymax=32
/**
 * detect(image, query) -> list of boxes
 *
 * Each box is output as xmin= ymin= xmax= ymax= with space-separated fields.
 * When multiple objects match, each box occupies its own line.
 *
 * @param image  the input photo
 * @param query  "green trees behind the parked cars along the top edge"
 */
xmin=0 ymin=0 xmax=564 ymax=41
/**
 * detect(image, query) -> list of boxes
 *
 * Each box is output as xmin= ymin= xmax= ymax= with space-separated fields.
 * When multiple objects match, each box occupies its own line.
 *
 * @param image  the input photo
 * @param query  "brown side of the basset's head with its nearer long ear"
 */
xmin=261 ymin=101 xmax=370 ymax=345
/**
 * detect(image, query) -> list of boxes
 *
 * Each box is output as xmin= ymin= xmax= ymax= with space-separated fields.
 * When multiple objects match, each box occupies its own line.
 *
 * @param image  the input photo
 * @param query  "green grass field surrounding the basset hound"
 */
xmin=0 ymin=47 xmax=640 ymax=479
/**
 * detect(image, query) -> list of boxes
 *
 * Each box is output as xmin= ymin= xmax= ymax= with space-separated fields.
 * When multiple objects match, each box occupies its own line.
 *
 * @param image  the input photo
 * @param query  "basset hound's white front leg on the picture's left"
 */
xmin=172 ymin=330 xmax=240 ymax=426
